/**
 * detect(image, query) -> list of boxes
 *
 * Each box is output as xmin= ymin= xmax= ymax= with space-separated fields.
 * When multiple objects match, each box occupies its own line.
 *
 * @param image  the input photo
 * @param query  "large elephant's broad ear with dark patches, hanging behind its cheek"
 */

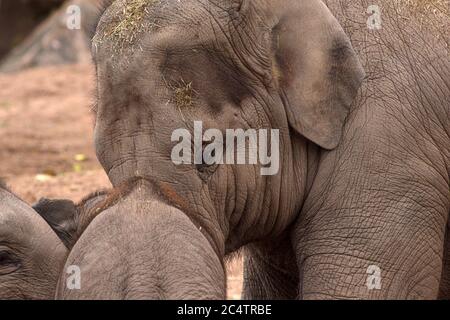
xmin=267 ymin=0 xmax=365 ymax=149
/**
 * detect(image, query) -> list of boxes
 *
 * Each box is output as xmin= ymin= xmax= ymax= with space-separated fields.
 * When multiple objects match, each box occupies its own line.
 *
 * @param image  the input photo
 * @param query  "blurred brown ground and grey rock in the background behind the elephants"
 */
xmin=0 ymin=0 xmax=242 ymax=299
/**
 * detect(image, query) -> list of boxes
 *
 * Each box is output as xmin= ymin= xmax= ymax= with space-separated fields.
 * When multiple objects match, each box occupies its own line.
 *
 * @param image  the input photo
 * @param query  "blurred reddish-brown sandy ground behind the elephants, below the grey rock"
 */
xmin=0 ymin=65 xmax=242 ymax=299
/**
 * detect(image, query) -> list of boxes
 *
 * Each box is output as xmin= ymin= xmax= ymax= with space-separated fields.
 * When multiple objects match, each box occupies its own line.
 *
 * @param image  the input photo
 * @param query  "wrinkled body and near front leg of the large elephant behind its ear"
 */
xmin=247 ymin=0 xmax=450 ymax=299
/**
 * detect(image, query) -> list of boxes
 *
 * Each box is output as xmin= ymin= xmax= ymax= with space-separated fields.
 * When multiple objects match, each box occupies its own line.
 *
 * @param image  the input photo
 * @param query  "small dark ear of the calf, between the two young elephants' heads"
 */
xmin=33 ymin=198 xmax=77 ymax=249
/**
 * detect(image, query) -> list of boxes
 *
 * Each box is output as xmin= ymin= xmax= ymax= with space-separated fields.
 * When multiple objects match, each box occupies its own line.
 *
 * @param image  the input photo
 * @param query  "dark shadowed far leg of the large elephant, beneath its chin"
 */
xmin=242 ymin=232 xmax=298 ymax=300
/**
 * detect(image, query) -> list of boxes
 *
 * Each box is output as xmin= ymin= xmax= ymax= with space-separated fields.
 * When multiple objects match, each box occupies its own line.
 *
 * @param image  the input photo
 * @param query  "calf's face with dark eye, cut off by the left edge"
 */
xmin=0 ymin=181 xmax=68 ymax=300
